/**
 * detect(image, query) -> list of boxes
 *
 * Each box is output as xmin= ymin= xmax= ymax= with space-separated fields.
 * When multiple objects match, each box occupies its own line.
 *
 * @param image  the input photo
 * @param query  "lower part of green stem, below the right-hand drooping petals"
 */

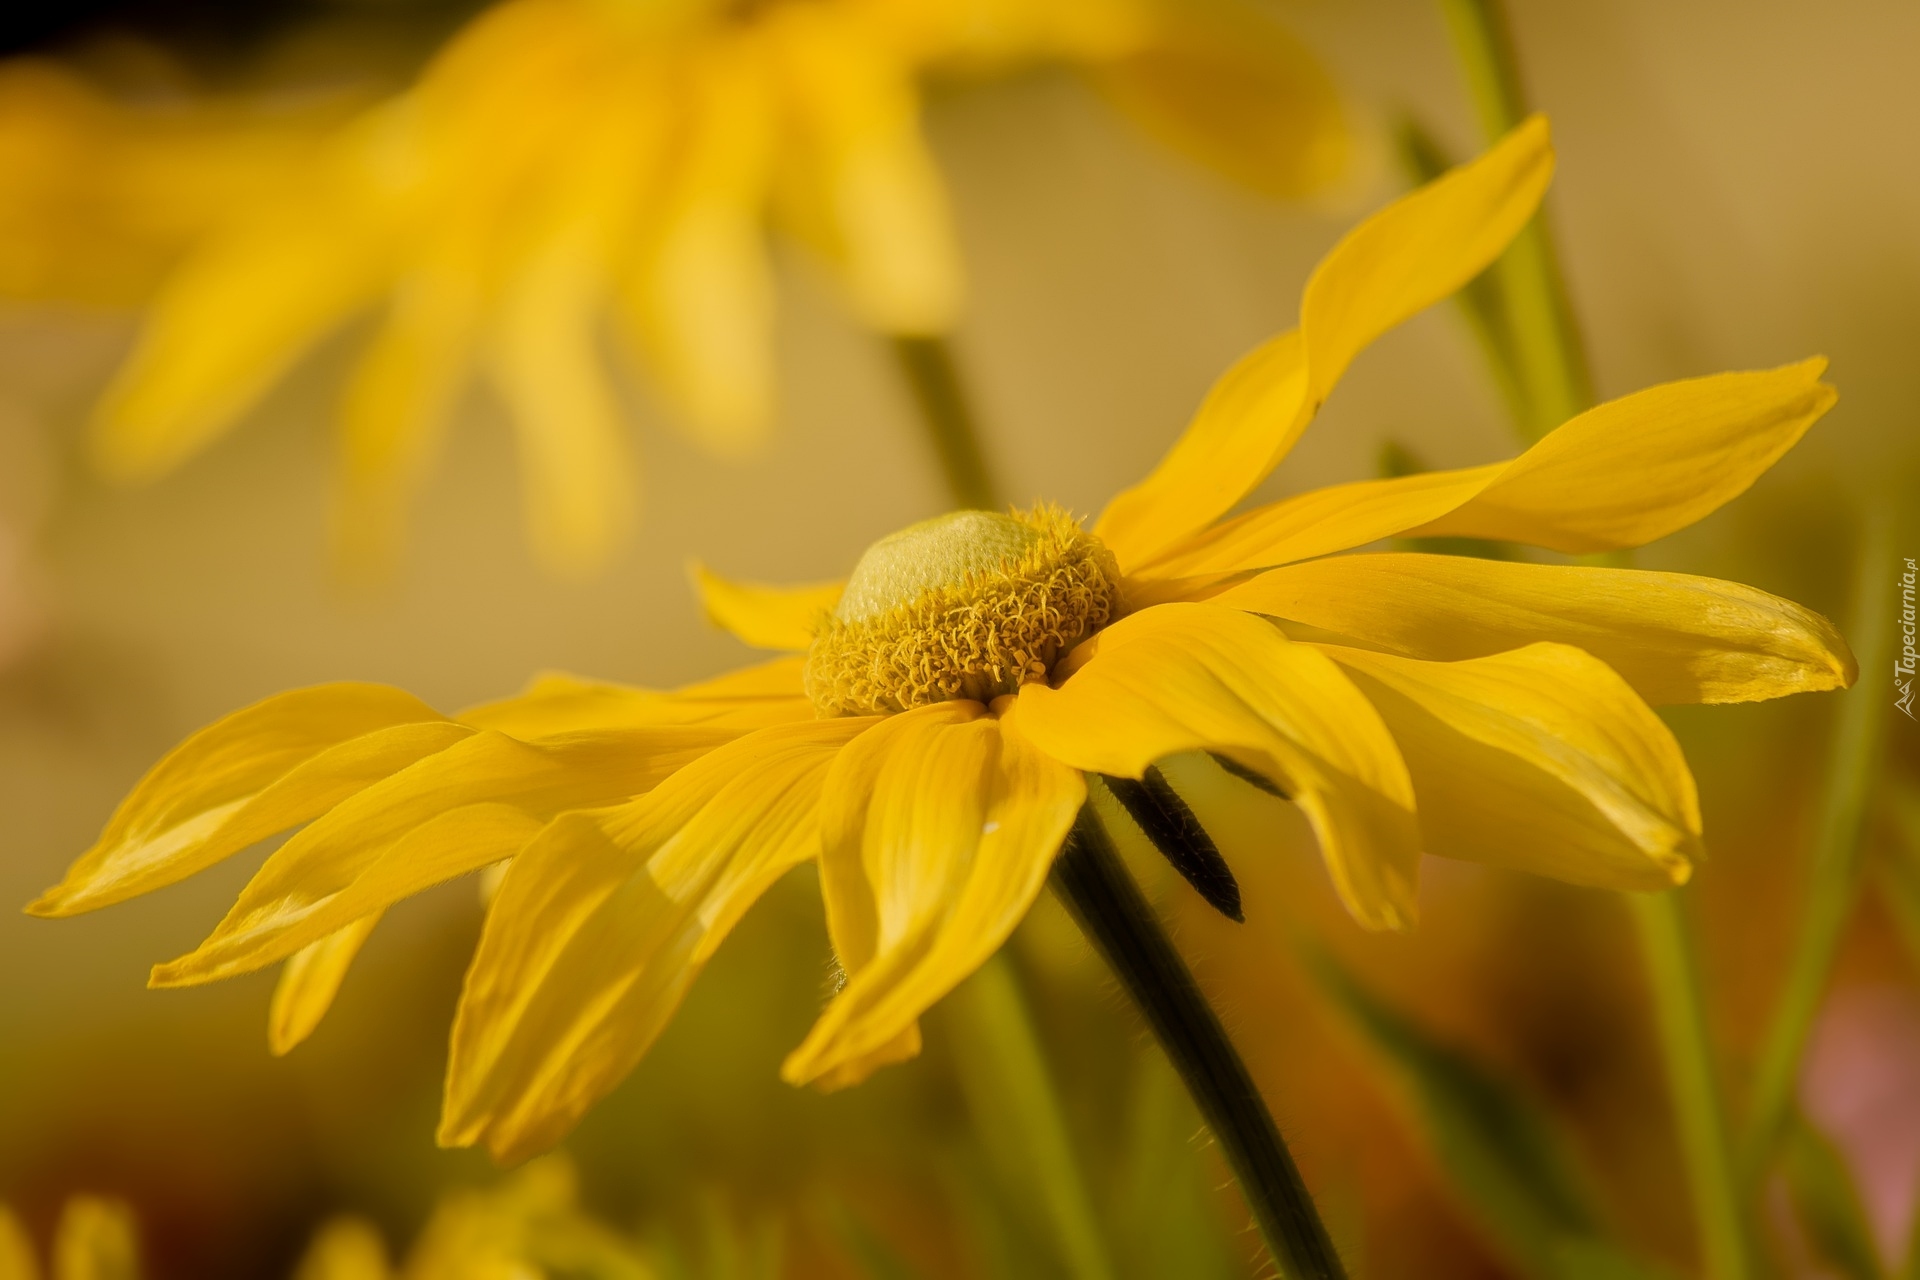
xmin=1624 ymin=892 xmax=1753 ymax=1280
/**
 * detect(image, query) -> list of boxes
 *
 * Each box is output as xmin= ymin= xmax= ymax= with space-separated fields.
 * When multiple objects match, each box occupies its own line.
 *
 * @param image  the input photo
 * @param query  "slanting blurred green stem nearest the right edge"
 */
xmin=1745 ymin=518 xmax=1897 ymax=1178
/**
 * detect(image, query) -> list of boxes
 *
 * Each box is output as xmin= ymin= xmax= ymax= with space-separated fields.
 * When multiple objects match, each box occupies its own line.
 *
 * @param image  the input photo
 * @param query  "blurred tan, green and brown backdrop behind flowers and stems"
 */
xmin=0 ymin=0 xmax=1920 ymax=1280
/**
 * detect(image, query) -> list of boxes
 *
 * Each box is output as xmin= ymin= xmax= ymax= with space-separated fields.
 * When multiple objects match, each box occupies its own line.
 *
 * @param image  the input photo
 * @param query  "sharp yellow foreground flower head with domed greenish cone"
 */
xmin=31 ymin=119 xmax=1853 ymax=1157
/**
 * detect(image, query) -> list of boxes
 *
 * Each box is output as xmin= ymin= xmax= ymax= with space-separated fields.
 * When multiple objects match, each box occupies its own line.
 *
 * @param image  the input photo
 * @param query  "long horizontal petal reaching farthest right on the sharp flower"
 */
xmin=1212 ymin=553 xmax=1855 ymax=704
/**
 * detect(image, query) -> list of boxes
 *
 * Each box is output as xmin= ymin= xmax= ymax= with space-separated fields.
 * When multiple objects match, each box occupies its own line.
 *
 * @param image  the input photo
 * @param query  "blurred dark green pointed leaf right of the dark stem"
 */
xmin=1302 ymin=942 xmax=1667 ymax=1280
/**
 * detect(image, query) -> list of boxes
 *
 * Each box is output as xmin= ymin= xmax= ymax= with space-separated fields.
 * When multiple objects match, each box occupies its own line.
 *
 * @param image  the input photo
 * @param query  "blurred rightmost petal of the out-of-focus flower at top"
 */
xmin=1092 ymin=3 xmax=1348 ymax=198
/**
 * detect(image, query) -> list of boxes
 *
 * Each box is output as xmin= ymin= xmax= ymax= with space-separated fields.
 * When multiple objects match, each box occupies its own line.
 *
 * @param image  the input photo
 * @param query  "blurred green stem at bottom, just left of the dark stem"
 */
xmin=947 ymin=952 xmax=1116 ymax=1280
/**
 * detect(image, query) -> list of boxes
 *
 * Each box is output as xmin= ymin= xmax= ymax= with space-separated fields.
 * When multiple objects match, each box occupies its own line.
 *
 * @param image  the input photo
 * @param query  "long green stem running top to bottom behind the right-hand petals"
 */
xmin=1440 ymin=0 xmax=1755 ymax=1280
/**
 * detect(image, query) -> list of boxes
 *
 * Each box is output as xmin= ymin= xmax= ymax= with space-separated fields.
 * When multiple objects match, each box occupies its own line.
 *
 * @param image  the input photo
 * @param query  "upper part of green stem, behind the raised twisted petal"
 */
xmin=1440 ymin=0 xmax=1594 ymax=439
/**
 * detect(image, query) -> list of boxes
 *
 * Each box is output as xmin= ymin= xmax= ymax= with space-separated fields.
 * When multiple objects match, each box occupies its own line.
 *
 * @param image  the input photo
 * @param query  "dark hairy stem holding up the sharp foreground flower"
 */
xmin=1052 ymin=802 xmax=1346 ymax=1280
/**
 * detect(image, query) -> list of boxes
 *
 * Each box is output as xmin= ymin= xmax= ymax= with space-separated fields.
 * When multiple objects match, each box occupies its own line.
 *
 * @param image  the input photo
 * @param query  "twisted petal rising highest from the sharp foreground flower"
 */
xmin=1094 ymin=117 xmax=1553 ymax=570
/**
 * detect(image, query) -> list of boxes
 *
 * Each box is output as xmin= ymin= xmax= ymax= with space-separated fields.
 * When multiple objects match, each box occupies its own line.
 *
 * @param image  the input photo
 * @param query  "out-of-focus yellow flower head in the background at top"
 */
xmin=52 ymin=0 xmax=1346 ymax=570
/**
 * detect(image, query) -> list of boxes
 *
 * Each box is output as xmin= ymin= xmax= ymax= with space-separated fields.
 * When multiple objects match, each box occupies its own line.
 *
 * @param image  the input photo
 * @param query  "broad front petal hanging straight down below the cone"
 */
xmin=780 ymin=702 xmax=1087 ymax=1084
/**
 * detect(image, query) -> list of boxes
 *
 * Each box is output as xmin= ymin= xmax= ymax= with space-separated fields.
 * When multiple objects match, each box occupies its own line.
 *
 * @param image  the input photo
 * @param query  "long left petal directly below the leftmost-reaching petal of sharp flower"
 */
xmin=150 ymin=725 xmax=737 ymax=986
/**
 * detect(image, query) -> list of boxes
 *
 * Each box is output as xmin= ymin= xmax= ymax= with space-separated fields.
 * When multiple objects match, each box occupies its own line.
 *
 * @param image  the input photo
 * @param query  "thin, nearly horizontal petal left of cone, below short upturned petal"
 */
xmin=459 ymin=658 xmax=814 ymax=739
